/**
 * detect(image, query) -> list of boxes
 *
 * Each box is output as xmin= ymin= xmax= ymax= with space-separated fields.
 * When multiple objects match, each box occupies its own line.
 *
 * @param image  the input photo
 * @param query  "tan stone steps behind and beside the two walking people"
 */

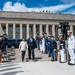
xmin=11 ymin=49 xmax=50 ymax=62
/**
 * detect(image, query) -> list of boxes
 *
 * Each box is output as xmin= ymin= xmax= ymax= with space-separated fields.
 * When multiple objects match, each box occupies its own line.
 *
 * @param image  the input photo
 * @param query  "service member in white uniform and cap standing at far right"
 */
xmin=67 ymin=31 xmax=75 ymax=64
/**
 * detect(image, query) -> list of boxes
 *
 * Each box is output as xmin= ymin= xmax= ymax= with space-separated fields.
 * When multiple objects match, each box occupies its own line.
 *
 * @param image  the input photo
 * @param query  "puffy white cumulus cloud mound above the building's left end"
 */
xmin=3 ymin=2 xmax=27 ymax=12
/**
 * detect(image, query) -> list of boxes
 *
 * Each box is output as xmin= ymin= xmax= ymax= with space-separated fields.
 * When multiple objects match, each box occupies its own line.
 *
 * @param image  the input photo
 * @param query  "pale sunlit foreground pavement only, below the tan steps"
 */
xmin=0 ymin=61 xmax=75 ymax=75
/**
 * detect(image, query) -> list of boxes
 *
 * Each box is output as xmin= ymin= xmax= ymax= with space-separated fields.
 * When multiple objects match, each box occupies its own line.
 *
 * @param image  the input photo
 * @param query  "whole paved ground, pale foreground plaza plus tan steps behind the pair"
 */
xmin=0 ymin=49 xmax=75 ymax=75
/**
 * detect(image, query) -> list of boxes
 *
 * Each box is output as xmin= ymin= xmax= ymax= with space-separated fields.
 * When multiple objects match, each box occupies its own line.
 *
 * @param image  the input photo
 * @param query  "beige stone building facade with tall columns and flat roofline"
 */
xmin=0 ymin=11 xmax=75 ymax=39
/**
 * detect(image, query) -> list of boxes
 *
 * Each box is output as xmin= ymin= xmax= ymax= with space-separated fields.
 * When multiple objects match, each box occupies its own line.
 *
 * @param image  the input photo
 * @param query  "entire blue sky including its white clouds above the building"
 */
xmin=0 ymin=0 xmax=75 ymax=14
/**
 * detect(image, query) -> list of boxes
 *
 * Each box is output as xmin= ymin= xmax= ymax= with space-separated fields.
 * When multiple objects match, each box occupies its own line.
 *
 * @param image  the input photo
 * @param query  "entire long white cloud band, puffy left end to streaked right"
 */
xmin=3 ymin=2 xmax=75 ymax=13
